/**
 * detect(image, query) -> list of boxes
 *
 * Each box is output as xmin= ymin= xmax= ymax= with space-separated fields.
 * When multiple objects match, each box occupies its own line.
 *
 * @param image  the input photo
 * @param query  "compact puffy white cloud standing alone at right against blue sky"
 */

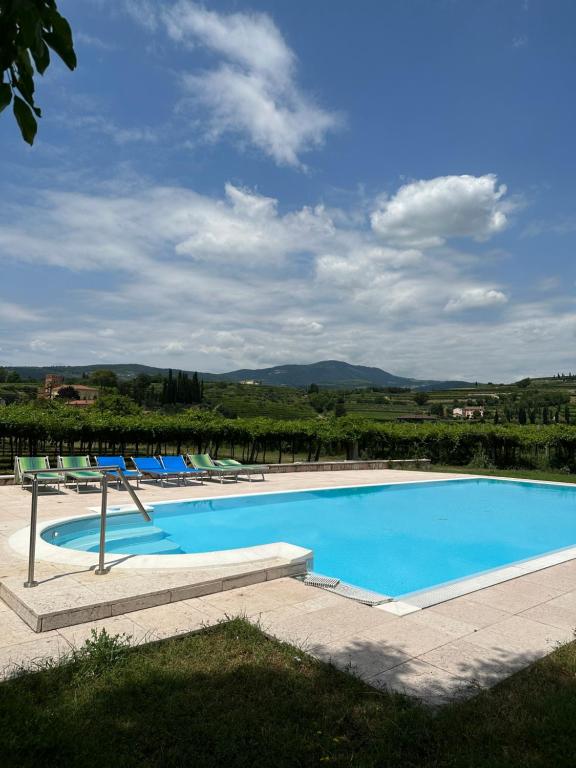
xmin=371 ymin=174 xmax=511 ymax=247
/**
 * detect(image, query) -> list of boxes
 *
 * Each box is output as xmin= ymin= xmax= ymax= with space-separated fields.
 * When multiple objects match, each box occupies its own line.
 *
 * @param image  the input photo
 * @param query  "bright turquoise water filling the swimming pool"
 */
xmin=42 ymin=479 xmax=576 ymax=597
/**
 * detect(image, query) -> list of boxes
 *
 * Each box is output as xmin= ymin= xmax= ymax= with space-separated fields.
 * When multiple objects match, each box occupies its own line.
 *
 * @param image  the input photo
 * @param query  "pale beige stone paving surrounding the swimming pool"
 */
xmin=0 ymin=470 xmax=576 ymax=704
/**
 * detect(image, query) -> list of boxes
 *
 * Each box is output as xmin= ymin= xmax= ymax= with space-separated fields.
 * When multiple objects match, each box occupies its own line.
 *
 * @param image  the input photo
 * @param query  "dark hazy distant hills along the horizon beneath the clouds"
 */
xmin=10 ymin=360 xmax=470 ymax=390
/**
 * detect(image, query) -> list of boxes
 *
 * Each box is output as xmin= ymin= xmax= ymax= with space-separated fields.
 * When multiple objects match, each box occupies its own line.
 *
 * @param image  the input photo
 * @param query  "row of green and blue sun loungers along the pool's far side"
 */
xmin=14 ymin=453 xmax=268 ymax=491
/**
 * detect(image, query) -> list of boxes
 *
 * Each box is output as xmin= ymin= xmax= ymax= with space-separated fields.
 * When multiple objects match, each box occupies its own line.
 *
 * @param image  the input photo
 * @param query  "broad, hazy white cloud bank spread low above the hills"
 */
xmin=0 ymin=172 xmax=564 ymax=380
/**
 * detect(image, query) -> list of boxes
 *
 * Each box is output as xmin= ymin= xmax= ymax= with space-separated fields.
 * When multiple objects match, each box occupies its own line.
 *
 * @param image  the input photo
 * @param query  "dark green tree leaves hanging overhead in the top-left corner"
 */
xmin=0 ymin=0 xmax=76 ymax=144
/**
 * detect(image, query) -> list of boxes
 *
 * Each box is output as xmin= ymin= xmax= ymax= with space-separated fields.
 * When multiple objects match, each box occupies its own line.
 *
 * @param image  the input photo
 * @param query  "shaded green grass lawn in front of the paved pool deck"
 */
xmin=0 ymin=619 xmax=576 ymax=768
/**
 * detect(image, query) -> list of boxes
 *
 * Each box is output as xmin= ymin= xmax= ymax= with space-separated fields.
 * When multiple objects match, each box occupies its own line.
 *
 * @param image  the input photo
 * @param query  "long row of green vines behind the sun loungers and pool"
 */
xmin=0 ymin=402 xmax=576 ymax=472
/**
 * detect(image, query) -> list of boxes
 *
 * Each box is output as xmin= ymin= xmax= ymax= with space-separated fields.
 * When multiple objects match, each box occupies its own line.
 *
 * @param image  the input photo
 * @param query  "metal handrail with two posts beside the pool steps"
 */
xmin=22 ymin=464 xmax=152 ymax=587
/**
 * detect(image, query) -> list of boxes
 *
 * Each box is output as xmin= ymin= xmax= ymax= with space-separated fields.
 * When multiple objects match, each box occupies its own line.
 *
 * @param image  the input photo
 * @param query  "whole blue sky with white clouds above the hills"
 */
xmin=0 ymin=0 xmax=576 ymax=382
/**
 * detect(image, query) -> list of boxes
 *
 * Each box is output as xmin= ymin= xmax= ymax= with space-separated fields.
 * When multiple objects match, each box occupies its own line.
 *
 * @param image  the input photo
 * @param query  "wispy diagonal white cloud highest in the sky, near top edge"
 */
xmin=161 ymin=0 xmax=340 ymax=167
